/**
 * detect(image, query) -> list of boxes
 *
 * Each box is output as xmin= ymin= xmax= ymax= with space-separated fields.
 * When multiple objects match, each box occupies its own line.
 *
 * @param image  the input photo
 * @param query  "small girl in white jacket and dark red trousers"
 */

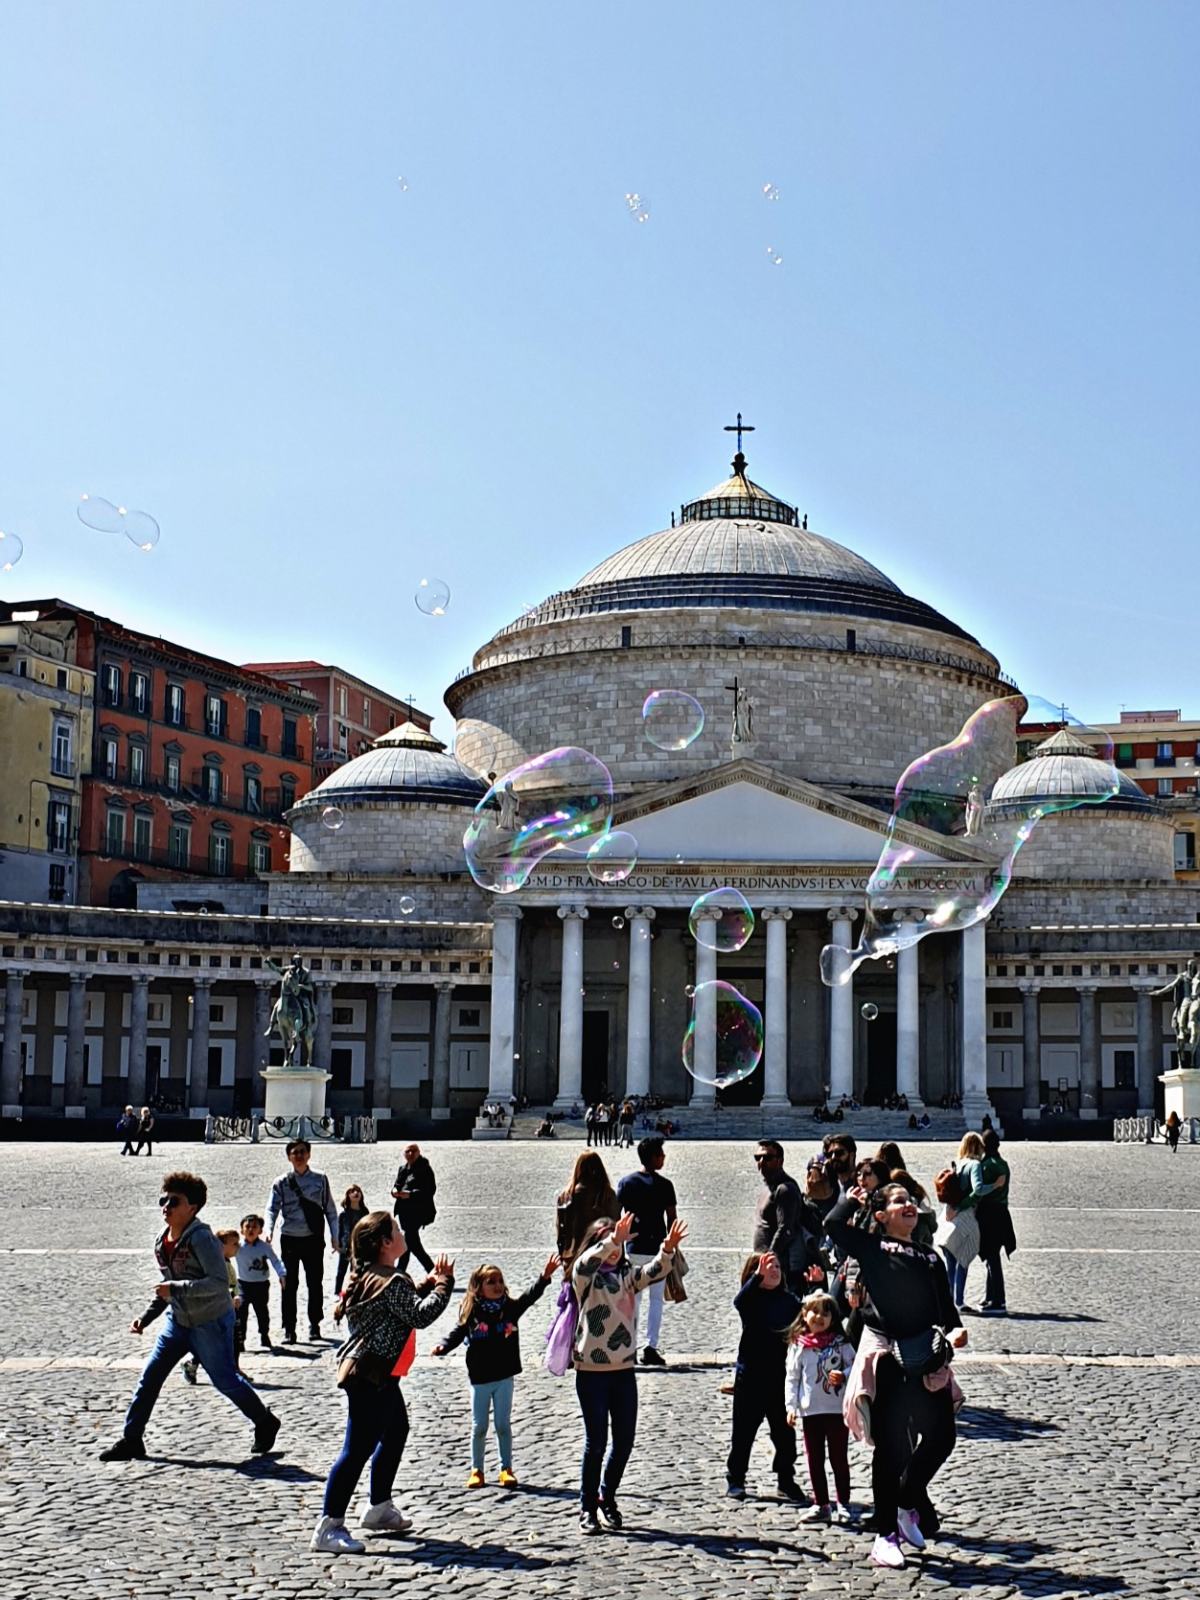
xmin=784 ymin=1291 xmax=854 ymax=1523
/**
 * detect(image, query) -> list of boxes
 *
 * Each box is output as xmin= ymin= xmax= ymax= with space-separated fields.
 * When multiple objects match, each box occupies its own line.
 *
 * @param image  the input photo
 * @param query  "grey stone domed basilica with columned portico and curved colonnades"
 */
xmin=0 ymin=451 xmax=1200 ymax=1126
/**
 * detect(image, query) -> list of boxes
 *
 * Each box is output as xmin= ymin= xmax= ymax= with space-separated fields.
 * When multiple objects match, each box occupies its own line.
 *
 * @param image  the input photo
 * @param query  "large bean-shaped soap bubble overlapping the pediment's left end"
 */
xmin=462 ymin=746 xmax=619 ymax=894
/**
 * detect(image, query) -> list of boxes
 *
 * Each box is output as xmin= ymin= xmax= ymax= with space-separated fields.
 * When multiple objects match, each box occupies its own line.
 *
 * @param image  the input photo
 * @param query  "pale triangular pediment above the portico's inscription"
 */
xmin=613 ymin=760 xmax=982 ymax=866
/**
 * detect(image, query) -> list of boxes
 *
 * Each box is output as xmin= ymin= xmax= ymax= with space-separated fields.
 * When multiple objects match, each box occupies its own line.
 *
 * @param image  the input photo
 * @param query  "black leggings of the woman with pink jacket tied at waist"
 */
xmin=870 ymin=1355 xmax=955 ymax=1533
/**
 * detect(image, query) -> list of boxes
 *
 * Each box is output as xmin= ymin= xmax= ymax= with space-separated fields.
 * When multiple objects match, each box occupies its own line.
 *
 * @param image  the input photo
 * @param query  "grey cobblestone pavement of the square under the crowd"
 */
xmin=0 ymin=1144 xmax=1200 ymax=1600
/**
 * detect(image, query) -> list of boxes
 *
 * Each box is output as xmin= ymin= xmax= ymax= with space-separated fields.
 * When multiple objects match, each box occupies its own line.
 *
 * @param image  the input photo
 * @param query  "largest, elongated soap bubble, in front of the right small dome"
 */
xmin=821 ymin=694 xmax=1122 ymax=987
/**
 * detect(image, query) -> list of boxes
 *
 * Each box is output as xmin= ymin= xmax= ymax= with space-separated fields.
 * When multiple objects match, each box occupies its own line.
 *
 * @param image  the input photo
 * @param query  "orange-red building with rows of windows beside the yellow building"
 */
xmin=0 ymin=600 xmax=317 ymax=906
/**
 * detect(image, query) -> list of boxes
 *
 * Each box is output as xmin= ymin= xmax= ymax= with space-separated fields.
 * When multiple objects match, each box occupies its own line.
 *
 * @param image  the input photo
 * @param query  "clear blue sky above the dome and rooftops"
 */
xmin=0 ymin=0 xmax=1200 ymax=736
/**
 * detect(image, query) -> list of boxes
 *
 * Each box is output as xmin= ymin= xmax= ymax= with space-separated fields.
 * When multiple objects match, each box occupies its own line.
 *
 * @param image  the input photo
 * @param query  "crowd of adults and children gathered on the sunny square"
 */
xmin=101 ymin=1126 xmax=1016 ymax=1566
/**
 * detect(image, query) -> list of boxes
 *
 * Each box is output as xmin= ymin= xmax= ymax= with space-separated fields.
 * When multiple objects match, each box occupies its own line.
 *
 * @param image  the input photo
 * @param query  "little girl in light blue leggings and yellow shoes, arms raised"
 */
xmin=434 ymin=1256 xmax=558 ymax=1490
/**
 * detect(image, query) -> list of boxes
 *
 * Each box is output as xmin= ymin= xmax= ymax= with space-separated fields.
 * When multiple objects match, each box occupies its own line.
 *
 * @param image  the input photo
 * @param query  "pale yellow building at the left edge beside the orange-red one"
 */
xmin=0 ymin=613 xmax=96 ymax=904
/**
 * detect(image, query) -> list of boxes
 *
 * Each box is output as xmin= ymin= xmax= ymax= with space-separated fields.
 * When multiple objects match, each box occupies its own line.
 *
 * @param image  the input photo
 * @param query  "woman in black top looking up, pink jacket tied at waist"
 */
xmin=826 ymin=1184 xmax=966 ymax=1566
